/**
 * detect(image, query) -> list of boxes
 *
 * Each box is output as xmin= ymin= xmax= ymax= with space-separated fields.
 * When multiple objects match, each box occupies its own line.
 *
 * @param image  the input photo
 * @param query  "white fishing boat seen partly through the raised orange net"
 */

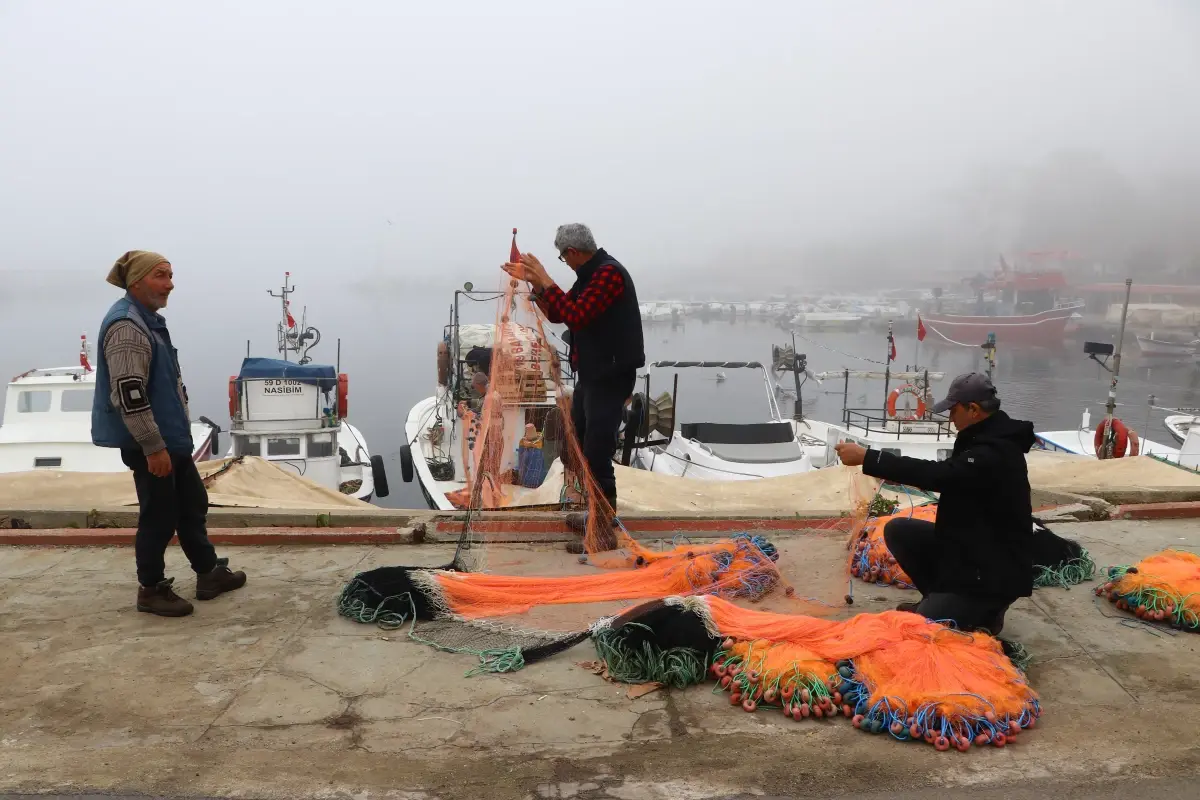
xmin=400 ymin=283 xmax=572 ymax=511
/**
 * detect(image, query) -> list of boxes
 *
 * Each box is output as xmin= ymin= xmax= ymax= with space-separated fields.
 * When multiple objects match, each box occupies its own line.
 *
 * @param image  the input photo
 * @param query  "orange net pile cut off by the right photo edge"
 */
xmin=1096 ymin=551 xmax=1200 ymax=631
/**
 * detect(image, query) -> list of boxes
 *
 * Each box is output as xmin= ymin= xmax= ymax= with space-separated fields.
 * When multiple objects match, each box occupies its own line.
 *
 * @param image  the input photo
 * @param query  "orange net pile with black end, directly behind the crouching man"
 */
xmin=850 ymin=504 xmax=1096 ymax=589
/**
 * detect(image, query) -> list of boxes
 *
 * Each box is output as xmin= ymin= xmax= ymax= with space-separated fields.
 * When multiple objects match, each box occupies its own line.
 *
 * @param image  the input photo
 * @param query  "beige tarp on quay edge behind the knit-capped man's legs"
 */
xmin=0 ymin=457 xmax=374 ymax=510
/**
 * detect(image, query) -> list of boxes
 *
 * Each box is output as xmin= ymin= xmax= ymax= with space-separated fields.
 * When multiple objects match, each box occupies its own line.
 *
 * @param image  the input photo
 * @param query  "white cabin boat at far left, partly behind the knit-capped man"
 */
xmin=0 ymin=333 xmax=221 ymax=473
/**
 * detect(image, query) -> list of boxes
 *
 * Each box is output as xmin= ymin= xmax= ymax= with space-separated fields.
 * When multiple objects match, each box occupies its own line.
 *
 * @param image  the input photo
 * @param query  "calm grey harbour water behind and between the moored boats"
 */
xmin=0 ymin=280 xmax=1200 ymax=507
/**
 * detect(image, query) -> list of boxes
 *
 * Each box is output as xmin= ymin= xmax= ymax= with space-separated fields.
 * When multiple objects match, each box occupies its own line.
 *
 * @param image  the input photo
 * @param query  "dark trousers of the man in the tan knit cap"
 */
xmin=121 ymin=450 xmax=217 ymax=587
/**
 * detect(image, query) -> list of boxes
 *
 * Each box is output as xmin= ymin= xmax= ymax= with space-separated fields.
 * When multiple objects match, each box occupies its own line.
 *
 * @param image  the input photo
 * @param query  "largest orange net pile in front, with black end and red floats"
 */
xmin=593 ymin=597 xmax=1040 ymax=751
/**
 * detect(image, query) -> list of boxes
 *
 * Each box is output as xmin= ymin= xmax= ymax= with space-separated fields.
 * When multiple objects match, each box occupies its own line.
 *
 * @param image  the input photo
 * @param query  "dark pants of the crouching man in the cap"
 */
xmin=883 ymin=518 xmax=1012 ymax=634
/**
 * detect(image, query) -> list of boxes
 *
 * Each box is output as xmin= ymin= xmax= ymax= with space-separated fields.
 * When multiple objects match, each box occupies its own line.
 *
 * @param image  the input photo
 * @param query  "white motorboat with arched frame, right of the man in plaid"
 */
xmin=630 ymin=361 xmax=812 ymax=481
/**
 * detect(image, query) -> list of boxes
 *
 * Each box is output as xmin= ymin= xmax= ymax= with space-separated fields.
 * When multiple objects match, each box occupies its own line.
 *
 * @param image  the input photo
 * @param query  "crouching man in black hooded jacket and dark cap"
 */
xmin=836 ymin=372 xmax=1033 ymax=636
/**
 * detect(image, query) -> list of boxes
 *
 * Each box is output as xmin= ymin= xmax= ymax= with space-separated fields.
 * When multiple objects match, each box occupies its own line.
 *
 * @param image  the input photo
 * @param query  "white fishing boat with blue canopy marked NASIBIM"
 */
xmin=228 ymin=272 xmax=388 ymax=503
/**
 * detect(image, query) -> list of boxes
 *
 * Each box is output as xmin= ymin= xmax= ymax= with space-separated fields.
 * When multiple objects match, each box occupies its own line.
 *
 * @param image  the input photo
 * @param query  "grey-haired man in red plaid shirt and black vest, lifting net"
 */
xmin=504 ymin=223 xmax=646 ymax=549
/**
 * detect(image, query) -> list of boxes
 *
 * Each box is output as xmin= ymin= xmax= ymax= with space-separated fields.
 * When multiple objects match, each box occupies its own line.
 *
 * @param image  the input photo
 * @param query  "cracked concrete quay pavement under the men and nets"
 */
xmin=0 ymin=521 xmax=1200 ymax=800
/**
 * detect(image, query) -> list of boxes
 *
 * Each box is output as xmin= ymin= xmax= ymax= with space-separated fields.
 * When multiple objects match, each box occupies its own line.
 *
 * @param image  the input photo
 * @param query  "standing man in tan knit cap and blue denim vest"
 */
xmin=91 ymin=249 xmax=246 ymax=616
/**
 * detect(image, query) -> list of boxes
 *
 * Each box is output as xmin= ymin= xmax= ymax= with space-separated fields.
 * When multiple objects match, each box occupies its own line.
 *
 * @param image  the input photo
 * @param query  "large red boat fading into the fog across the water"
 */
xmin=922 ymin=253 xmax=1084 ymax=347
